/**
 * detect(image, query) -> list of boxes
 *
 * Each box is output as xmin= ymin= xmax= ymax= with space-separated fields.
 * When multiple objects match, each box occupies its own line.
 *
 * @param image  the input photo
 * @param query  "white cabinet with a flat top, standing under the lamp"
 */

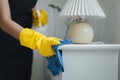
xmin=59 ymin=44 xmax=120 ymax=80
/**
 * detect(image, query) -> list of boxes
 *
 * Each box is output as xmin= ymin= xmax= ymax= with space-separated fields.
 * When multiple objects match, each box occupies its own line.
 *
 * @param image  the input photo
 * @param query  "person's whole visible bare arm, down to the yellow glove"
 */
xmin=0 ymin=0 xmax=23 ymax=39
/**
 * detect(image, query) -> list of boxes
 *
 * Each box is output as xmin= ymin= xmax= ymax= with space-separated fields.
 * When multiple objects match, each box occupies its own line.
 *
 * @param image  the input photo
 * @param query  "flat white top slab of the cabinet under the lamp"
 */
xmin=59 ymin=44 xmax=120 ymax=50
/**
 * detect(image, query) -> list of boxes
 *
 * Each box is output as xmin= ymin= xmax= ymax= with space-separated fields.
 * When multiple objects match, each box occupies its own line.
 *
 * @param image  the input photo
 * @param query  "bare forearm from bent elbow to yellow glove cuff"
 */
xmin=0 ymin=20 xmax=23 ymax=39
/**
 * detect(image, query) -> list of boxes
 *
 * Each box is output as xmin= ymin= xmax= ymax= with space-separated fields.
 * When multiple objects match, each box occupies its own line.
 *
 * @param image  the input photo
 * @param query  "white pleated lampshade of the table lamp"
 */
xmin=60 ymin=0 xmax=105 ymax=17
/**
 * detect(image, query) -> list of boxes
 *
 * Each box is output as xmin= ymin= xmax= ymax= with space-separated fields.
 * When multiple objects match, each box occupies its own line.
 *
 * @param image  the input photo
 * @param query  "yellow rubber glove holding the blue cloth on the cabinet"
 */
xmin=19 ymin=28 xmax=60 ymax=57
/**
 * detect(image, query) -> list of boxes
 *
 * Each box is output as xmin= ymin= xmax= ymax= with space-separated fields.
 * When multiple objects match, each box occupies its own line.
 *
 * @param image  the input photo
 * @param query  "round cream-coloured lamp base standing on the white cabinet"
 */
xmin=69 ymin=22 xmax=94 ymax=43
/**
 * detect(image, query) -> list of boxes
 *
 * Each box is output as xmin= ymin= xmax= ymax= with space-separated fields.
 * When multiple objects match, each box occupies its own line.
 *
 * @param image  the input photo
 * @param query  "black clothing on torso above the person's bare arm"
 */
xmin=9 ymin=0 xmax=37 ymax=27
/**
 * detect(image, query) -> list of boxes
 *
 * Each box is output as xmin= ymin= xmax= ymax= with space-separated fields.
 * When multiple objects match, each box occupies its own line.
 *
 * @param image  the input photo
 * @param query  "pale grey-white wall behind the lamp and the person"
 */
xmin=32 ymin=0 xmax=120 ymax=80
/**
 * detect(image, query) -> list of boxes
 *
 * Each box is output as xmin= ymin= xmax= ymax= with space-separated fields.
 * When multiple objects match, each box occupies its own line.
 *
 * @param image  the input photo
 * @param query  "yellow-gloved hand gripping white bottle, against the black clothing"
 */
xmin=32 ymin=9 xmax=48 ymax=28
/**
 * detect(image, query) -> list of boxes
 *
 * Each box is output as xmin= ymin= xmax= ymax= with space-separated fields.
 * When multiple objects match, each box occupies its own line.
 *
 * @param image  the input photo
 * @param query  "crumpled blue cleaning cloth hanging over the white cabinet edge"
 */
xmin=46 ymin=40 xmax=72 ymax=76
